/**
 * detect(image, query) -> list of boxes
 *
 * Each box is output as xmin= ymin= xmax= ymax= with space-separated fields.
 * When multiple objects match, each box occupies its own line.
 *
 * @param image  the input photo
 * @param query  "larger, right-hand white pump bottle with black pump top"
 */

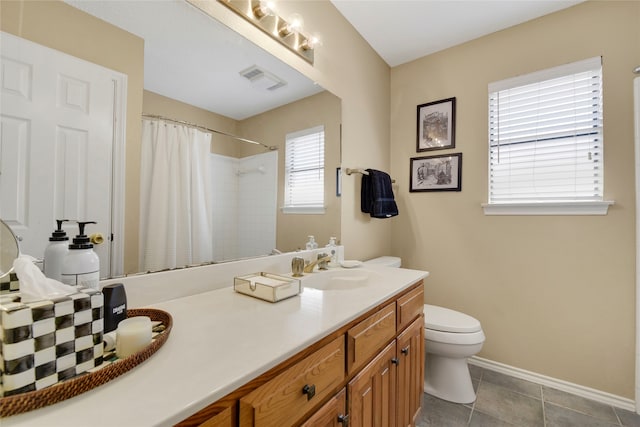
xmin=61 ymin=221 xmax=100 ymax=290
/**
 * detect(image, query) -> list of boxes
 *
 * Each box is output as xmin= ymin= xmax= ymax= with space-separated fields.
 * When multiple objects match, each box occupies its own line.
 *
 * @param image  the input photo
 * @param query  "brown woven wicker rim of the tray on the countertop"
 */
xmin=0 ymin=308 xmax=173 ymax=417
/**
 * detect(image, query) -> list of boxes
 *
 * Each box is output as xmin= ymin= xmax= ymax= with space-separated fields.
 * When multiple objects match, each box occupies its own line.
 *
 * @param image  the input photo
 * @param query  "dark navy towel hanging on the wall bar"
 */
xmin=360 ymin=169 xmax=398 ymax=218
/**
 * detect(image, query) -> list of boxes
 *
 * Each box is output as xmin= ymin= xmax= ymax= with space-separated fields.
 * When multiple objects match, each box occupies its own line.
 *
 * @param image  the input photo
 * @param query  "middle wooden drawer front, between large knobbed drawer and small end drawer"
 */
xmin=347 ymin=302 xmax=396 ymax=374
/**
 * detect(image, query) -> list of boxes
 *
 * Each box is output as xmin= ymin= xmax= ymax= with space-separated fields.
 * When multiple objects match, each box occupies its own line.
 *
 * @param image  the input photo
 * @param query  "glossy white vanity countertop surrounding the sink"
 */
xmin=1 ymin=266 xmax=428 ymax=427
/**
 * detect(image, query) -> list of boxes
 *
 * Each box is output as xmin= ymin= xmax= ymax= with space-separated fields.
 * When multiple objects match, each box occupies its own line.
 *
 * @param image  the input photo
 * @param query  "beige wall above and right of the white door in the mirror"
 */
xmin=0 ymin=0 xmax=144 ymax=272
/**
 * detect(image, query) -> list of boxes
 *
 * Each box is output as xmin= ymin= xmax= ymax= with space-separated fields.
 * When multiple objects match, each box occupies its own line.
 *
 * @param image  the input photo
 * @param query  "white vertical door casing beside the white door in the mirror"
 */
xmin=108 ymin=71 xmax=127 ymax=277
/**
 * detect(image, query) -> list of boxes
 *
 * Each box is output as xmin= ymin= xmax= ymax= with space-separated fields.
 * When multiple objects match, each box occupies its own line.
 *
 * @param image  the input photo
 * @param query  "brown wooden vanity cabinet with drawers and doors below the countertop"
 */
xmin=179 ymin=281 xmax=424 ymax=427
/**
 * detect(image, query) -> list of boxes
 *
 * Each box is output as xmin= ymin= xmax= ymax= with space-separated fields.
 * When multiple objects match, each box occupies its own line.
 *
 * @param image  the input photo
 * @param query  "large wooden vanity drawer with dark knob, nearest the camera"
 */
xmin=240 ymin=335 xmax=345 ymax=427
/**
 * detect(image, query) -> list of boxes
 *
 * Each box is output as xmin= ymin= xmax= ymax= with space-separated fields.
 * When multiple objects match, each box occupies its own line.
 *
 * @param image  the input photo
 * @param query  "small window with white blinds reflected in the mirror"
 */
xmin=282 ymin=126 xmax=324 ymax=214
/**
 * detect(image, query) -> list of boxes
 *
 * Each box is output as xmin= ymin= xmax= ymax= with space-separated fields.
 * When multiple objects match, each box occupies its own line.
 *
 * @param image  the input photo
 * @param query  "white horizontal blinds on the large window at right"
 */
xmin=489 ymin=57 xmax=604 ymax=204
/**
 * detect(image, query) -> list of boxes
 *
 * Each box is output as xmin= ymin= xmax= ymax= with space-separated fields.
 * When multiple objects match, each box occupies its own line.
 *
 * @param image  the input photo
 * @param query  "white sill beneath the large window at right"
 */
xmin=481 ymin=200 xmax=615 ymax=215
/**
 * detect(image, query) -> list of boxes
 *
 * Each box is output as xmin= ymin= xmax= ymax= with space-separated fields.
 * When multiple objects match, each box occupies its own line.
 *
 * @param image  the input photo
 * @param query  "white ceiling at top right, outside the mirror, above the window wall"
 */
xmin=331 ymin=0 xmax=584 ymax=67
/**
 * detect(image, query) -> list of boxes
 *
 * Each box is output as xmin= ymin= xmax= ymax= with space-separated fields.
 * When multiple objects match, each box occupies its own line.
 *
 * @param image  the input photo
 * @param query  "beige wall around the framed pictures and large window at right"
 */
xmin=391 ymin=2 xmax=640 ymax=398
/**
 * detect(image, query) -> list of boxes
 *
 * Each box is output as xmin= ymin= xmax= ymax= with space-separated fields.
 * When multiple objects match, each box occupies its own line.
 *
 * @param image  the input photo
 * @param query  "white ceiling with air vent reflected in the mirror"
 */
xmin=65 ymin=0 xmax=324 ymax=120
